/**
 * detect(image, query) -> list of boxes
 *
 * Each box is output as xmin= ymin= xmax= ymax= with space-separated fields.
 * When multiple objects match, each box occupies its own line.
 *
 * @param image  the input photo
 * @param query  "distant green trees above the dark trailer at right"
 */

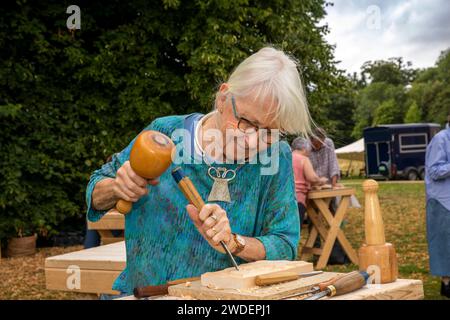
xmin=352 ymin=50 xmax=450 ymax=139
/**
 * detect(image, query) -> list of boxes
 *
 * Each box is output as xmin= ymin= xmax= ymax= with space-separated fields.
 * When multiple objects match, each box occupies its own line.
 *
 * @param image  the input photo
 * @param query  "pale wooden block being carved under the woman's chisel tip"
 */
xmin=201 ymin=260 xmax=314 ymax=290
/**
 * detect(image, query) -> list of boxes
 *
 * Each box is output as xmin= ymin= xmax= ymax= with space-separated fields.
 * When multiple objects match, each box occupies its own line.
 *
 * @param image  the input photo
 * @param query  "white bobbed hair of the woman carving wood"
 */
xmin=221 ymin=47 xmax=312 ymax=136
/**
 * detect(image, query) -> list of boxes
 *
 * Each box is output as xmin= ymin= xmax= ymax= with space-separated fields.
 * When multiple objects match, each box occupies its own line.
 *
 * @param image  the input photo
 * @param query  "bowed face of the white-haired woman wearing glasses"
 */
xmin=216 ymin=83 xmax=279 ymax=160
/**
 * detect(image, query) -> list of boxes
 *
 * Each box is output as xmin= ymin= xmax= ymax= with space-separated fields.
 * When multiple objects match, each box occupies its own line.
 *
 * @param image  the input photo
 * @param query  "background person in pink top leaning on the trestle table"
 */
xmin=291 ymin=137 xmax=328 ymax=226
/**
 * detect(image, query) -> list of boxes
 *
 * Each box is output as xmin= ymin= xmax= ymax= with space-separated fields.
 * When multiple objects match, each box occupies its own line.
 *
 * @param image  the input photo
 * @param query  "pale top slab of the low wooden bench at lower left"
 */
xmin=45 ymin=241 xmax=126 ymax=271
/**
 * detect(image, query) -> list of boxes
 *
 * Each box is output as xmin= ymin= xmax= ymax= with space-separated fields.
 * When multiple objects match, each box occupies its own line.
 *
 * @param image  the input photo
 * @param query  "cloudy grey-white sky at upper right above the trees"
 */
xmin=324 ymin=0 xmax=450 ymax=72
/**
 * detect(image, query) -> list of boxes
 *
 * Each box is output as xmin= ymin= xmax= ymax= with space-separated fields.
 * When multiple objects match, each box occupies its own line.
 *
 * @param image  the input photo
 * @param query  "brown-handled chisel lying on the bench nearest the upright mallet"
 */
xmin=303 ymin=271 xmax=369 ymax=300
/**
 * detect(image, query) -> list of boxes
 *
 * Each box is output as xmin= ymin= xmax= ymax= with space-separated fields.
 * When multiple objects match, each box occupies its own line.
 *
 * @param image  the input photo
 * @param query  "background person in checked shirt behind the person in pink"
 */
xmin=309 ymin=128 xmax=340 ymax=188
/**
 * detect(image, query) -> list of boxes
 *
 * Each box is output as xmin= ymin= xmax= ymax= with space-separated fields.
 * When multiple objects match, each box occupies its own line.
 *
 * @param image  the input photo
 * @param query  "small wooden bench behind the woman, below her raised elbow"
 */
xmin=88 ymin=209 xmax=125 ymax=245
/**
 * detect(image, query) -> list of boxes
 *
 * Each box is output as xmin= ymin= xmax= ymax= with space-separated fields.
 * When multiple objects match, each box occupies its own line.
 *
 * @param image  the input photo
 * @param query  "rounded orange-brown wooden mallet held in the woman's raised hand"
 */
xmin=116 ymin=130 xmax=175 ymax=214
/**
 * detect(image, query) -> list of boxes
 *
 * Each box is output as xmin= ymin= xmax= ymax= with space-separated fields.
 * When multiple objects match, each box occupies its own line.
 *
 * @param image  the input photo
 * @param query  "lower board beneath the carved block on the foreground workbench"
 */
xmin=169 ymin=272 xmax=336 ymax=300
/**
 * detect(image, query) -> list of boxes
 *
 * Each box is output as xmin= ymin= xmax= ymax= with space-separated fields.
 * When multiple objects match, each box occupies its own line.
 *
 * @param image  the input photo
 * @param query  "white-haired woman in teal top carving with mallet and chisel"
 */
xmin=86 ymin=48 xmax=310 ymax=294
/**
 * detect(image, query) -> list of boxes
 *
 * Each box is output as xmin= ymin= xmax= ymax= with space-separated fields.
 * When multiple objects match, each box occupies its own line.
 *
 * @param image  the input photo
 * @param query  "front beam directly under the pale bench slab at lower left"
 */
xmin=45 ymin=268 xmax=120 ymax=294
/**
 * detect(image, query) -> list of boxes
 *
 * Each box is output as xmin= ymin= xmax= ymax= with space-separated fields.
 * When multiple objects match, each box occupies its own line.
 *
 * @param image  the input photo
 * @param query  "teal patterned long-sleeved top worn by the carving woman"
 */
xmin=86 ymin=116 xmax=300 ymax=294
